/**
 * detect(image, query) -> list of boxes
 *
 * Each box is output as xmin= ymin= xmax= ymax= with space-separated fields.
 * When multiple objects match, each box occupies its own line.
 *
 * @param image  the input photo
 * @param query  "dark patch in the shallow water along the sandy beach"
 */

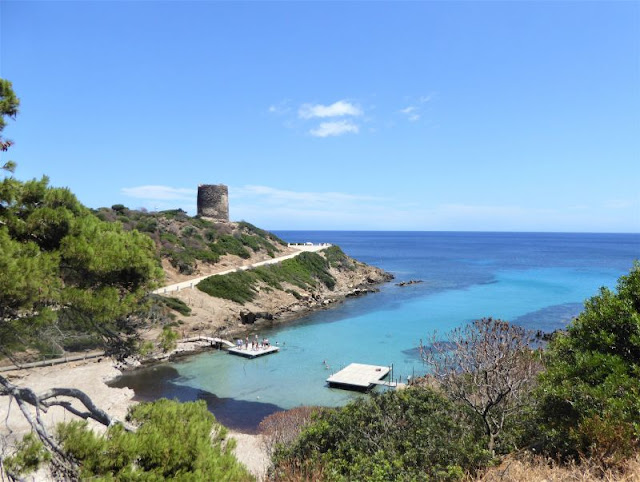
xmin=108 ymin=365 xmax=283 ymax=433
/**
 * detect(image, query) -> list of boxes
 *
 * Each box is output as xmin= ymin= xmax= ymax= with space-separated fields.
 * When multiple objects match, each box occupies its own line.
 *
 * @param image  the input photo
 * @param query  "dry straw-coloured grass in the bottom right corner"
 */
xmin=476 ymin=454 xmax=640 ymax=482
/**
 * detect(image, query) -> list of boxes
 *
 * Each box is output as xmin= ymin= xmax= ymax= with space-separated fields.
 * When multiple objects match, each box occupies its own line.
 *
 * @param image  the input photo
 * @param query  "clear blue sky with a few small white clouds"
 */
xmin=0 ymin=0 xmax=640 ymax=232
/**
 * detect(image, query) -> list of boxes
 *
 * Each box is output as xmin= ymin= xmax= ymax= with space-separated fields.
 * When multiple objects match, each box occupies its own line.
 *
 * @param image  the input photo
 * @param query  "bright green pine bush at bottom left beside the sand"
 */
xmin=58 ymin=399 xmax=253 ymax=481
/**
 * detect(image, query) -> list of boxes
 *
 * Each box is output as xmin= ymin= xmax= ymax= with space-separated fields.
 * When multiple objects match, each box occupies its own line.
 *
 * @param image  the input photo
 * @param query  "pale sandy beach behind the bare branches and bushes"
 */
xmin=0 ymin=357 xmax=269 ymax=481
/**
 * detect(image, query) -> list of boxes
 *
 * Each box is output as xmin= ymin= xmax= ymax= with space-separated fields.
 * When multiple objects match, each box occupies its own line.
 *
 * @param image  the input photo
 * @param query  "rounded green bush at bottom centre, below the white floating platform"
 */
xmin=271 ymin=388 xmax=491 ymax=481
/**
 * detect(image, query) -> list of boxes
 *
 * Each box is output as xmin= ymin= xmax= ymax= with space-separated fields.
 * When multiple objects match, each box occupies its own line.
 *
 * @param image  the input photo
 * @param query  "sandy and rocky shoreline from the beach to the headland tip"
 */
xmin=0 ymin=275 xmax=390 ymax=480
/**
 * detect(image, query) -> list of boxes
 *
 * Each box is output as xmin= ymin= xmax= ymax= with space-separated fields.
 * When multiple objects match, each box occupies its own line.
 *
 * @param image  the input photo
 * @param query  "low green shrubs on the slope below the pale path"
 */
xmin=197 ymin=248 xmax=346 ymax=304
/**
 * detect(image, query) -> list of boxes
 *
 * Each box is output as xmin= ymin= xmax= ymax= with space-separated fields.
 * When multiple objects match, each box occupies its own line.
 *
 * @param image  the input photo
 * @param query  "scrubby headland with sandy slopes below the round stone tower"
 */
xmin=95 ymin=205 xmax=393 ymax=339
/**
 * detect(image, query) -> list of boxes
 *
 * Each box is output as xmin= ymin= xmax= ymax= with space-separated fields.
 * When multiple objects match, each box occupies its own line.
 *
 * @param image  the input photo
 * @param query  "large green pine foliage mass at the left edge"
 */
xmin=0 ymin=177 xmax=162 ymax=352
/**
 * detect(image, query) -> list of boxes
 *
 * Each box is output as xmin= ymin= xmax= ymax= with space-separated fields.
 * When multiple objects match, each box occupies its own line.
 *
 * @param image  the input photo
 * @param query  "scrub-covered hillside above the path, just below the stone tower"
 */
xmin=95 ymin=204 xmax=286 ymax=275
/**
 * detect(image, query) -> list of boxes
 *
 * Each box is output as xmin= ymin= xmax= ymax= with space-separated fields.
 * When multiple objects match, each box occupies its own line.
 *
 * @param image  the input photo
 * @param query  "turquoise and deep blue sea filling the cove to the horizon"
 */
xmin=112 ymin=231 xmax=640 ymax=433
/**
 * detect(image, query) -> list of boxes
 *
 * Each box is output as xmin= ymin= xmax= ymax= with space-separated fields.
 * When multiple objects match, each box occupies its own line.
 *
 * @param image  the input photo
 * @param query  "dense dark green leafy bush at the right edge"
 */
xmin=532 ymin=263 xmax=640 ymax=465
